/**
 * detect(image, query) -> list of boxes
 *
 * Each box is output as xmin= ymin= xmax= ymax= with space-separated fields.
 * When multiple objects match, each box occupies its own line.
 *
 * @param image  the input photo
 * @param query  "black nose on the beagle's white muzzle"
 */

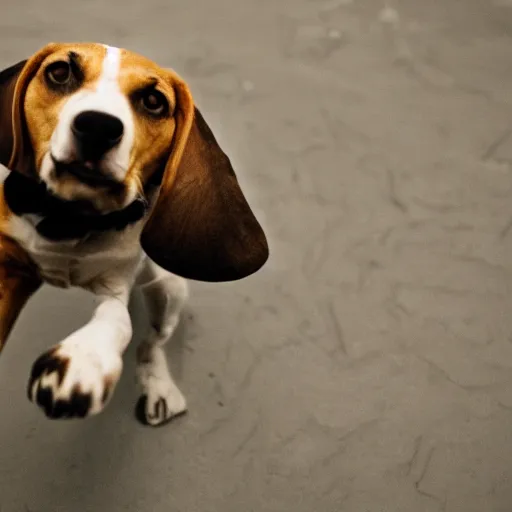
xmin=71 ymin=110 xmax=124 ymax=162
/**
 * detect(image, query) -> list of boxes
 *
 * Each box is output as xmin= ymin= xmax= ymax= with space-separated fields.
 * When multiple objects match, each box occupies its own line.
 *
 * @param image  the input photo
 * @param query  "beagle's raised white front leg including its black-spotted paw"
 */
xmin=28 ymin=276 xmax=132 ymax=418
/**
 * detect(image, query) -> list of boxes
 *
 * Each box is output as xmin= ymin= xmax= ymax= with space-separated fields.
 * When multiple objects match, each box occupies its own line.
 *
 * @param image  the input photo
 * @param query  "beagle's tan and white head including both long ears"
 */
xmin=0 ymin=44 xmax=268 ymax=281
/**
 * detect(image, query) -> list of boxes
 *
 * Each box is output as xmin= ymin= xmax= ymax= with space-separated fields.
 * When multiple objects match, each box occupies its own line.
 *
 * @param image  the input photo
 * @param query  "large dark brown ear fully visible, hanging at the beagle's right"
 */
xmin=141 ymin=78 xmax=268 ymax=282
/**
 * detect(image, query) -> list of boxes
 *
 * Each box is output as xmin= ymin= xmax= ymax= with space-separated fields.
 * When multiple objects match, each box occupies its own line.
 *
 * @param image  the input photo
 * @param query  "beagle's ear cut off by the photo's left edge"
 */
xmin=0 ymin=44 xmax=56 ymax=174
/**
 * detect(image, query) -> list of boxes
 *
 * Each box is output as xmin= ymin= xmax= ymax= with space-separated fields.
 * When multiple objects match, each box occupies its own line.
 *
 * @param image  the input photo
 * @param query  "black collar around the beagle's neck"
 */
xmin=4 ymin=171 xmax=146 ymax=241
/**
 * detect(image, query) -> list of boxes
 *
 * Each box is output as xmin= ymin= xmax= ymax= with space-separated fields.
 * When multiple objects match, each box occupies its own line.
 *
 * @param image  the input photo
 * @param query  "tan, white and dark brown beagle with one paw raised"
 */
xmin=0 ymin=43 xmax=268 ymax=426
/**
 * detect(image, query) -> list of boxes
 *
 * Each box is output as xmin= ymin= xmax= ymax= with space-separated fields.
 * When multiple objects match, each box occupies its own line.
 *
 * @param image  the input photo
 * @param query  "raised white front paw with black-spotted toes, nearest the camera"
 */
xmin=28 ymin=340 xmax=123 ymax=418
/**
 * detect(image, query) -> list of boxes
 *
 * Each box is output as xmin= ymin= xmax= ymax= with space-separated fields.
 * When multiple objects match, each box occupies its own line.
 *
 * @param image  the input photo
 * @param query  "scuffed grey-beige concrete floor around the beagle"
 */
xmin=0 ymin=0 xmax=512 ymax=512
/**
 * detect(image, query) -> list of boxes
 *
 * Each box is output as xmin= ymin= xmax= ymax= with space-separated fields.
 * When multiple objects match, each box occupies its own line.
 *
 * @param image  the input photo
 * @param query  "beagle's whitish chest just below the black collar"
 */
xmin=9 ymin=215 xmax=141 ymax=288
